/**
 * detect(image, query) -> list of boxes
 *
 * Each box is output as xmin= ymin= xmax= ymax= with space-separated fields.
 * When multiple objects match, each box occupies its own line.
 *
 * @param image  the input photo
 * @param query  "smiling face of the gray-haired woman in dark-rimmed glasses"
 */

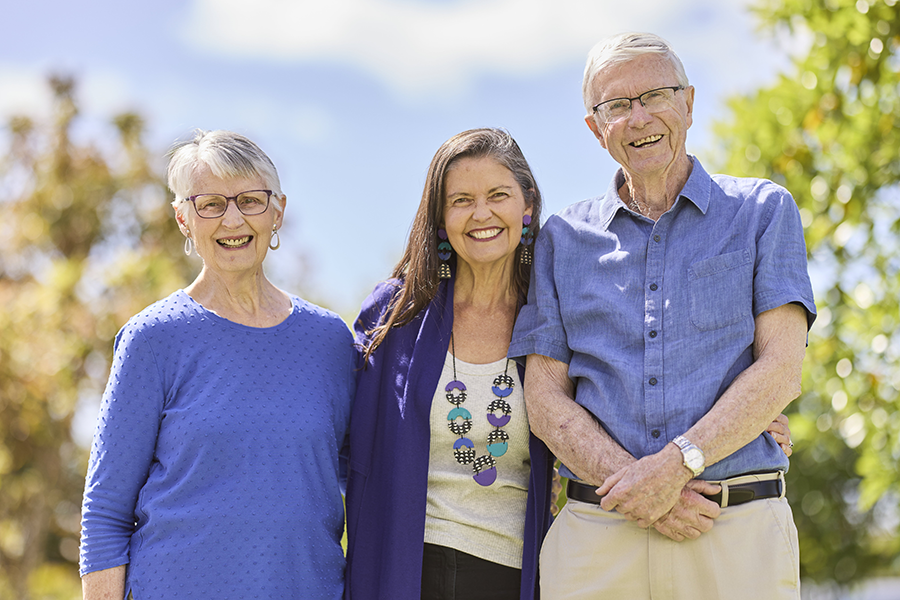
xmin=177 ymin=165 xmax=286 ymax=274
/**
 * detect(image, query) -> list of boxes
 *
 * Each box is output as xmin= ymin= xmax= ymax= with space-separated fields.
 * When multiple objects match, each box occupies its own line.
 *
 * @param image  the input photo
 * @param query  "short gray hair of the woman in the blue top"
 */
xmin=166 ymin=129 xmax=283 ymax=219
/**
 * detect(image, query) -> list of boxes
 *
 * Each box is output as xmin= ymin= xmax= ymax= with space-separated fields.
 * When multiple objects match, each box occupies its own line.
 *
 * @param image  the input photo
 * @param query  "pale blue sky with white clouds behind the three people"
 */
xmin=0 ymin=0 xmax=789 ymax=320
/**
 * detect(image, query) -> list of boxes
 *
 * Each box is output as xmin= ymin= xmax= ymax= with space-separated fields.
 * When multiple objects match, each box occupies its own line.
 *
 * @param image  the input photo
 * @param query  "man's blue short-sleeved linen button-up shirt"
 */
xmin=509 ymin=158 xmax=815 ymax=480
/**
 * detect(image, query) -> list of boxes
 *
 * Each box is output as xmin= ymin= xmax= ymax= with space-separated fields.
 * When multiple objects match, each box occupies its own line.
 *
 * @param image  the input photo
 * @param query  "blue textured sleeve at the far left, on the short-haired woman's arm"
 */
xmin=80 ymin=324 xmax=165 ymax=575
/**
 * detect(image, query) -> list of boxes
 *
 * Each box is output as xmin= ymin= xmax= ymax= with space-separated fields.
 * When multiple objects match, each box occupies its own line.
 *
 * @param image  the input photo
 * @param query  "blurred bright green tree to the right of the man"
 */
xmin=715 ymin=0 xmax=900 ymax=584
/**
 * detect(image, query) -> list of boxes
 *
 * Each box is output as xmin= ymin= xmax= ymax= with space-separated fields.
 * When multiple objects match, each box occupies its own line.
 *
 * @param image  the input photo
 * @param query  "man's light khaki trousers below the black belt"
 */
xmin=540 ymin=498 xmax=800 ymax=600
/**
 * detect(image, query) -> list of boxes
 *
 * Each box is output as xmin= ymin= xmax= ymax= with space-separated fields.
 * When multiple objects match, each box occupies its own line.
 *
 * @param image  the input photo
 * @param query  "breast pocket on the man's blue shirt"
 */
xmin=688 ymin=250 xmax=753 ymax=331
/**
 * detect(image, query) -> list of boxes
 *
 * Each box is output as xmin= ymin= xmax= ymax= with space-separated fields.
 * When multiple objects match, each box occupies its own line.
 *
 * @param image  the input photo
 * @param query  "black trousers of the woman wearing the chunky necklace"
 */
xmin=422 ymin=544 xmax=522 ymax=600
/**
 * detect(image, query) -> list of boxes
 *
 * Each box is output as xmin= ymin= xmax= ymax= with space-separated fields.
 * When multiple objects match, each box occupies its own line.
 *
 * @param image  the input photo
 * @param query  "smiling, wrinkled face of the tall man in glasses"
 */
xmin=585 ymin=54 xmax=694 ymax=184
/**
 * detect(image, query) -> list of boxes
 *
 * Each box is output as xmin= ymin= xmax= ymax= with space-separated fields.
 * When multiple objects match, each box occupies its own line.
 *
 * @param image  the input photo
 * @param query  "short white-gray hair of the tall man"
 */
xmin=581 ymin=33 xmax=690 ymax=115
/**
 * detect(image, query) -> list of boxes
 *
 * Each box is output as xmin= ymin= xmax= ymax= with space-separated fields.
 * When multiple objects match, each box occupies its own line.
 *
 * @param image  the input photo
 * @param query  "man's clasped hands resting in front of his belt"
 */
xmin=597 ymin=445 xmax=721 ymax=542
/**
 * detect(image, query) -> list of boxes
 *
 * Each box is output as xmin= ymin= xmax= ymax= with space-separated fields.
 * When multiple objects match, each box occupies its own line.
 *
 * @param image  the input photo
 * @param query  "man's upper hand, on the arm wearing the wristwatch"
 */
xmin=597 ymin=444 xmax=691 ymax=529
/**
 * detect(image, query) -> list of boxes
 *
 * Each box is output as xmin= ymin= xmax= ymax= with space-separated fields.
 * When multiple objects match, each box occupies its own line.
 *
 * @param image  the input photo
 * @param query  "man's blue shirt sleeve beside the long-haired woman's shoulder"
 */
xmin=509 ymin=215 xmax=572 ymax=365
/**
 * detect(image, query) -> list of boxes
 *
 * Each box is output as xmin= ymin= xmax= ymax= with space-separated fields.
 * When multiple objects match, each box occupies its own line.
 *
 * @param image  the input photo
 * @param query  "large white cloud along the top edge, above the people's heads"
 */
xmin=183 ymin=0 xmax=752 ymax=94
